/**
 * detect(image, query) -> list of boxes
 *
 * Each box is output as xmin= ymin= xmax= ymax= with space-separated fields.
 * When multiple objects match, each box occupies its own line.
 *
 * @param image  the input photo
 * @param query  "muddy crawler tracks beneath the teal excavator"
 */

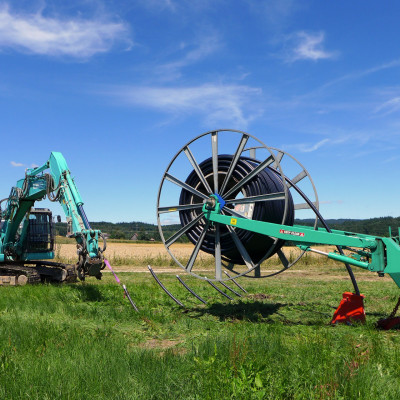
xmin=0 ymin=261 xmax=78 ymax=286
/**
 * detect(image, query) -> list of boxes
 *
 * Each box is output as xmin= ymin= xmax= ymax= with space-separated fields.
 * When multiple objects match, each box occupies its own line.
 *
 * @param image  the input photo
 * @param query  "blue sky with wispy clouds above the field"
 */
xmin=0 ymin=0 xmax=400 ymax=222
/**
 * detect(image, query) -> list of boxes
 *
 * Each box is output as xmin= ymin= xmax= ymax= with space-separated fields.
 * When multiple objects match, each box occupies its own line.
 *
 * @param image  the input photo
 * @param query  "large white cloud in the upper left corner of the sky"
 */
xmin=0 ymin=5 xmax=128 ymax=58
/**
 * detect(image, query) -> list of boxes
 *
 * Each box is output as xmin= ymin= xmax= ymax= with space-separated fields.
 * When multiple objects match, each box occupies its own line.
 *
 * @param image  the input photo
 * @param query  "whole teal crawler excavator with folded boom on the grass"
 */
xmin=0 ymin=152 xmax=106 ymax=285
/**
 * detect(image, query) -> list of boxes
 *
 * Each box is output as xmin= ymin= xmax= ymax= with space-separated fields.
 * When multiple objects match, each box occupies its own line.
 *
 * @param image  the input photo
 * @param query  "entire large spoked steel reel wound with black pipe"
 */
xmin=157 ymin=129 xmax=359 ymax=293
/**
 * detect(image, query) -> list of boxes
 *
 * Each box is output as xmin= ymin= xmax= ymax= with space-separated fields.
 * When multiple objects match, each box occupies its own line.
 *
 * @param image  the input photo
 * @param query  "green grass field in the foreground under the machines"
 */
xmin=0 ymin=265 xmax=400 ymax=400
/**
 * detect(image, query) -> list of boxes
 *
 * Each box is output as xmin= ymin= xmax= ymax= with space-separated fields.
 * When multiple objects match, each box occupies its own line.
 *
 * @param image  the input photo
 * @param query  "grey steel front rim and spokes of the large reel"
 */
xmin=157 ymin=129 xmax=289 ymax=282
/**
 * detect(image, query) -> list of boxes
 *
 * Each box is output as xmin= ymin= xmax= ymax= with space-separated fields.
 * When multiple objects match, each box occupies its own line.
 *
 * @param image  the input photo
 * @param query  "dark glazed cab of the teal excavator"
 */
xmin=27 ymin=208 xmax=54 ymax=253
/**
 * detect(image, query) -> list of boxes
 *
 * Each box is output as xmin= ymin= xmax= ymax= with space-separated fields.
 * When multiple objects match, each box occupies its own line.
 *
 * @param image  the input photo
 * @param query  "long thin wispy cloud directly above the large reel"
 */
xmin=103 ymin=84 xmax=262 ymax=128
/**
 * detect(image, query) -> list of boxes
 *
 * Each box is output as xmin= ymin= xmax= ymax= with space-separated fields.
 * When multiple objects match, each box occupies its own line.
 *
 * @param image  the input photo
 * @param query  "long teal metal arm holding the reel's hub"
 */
xmin=203 ymin=199 xmax=400 ymax=287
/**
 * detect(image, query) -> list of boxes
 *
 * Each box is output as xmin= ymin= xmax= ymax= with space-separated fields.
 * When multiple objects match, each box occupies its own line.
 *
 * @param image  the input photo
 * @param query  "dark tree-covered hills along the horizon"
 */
xmin=56 ymin=217 xmax=400 ymax=242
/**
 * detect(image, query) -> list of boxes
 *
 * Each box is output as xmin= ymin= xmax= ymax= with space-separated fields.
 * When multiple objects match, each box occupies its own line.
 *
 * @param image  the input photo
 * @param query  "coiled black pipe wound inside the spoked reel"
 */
xmin=179 ymin=155 xmax=294 ymax=265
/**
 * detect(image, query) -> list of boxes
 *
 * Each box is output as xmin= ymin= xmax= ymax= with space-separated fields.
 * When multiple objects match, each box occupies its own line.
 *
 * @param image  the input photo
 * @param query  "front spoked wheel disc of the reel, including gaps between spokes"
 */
xmin=157 ymin=130 xmax=294 ymax=281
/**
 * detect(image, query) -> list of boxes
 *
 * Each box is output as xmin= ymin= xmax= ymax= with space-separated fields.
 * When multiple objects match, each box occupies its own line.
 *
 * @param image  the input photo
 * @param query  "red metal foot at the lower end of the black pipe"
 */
xmin=331 ymin=292 xmax=365 ymax=325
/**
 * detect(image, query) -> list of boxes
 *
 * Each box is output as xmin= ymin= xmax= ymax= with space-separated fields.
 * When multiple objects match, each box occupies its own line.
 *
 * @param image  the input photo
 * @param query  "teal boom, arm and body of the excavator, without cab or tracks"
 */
xmin=0 ymin=152 xmax=103 ymax=275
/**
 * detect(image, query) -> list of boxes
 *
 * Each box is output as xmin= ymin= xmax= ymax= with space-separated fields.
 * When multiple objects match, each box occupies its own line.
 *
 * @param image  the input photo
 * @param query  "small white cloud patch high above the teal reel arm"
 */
xmin=286 ymin=31 xmax=337 ymax=62
